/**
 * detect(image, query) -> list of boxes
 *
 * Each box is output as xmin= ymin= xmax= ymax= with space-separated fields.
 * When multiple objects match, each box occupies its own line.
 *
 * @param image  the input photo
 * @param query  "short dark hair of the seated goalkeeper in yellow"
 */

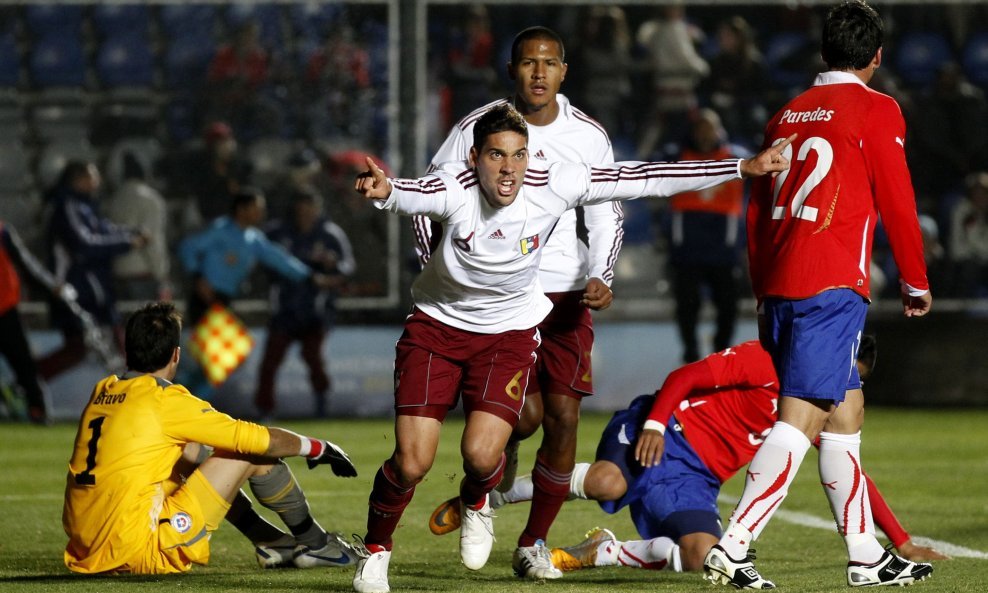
xmin=124 ymin=301 xmax=182 ymax=373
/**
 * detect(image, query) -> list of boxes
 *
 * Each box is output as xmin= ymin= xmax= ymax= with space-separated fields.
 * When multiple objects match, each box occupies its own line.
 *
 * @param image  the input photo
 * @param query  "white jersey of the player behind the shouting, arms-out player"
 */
xmin=415 ymin=94 xmax=624 ymax=292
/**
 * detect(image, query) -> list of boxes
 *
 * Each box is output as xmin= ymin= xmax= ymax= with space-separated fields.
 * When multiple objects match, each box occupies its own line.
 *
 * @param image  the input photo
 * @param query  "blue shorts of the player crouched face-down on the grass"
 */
xmin=597 ymin=395 xmax=721 ymax=540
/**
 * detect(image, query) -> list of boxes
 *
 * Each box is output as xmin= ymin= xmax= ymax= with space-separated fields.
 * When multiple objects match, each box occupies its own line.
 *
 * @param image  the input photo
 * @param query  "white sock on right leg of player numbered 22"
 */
xmin=820 ymin=431 xmax=885 ymax=564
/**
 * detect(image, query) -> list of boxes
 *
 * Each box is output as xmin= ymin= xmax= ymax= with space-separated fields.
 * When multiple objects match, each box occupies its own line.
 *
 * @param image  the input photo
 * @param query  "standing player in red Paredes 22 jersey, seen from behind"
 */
xmin=704 ymin=1 xmax=933 ymax=589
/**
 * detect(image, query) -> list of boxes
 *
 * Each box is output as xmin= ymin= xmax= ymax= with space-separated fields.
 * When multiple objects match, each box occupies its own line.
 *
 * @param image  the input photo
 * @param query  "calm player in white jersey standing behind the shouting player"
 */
xmin=414 ymin=27 xmax=624 ymax=579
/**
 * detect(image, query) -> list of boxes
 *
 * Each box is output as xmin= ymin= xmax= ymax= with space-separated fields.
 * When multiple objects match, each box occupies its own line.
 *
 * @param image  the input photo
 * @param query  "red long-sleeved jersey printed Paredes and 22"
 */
xmin=747 ymin=72 xmax=929 ymax=300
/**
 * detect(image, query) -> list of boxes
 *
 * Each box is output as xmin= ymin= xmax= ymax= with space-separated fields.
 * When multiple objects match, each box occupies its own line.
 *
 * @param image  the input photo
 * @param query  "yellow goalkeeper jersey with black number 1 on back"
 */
xmin=62 ymin=373 xmax=270 ymax=573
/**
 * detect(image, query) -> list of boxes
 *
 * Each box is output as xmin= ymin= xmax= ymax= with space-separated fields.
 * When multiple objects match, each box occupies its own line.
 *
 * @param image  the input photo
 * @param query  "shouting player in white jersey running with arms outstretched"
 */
xmin=353 ymin=105 xmax=789 ymax=593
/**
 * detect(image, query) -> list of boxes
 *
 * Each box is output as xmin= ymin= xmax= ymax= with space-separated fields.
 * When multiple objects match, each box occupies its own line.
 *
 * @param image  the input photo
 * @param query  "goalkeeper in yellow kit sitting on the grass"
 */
xmin=62 ymin=303 xmax=357 ymax=574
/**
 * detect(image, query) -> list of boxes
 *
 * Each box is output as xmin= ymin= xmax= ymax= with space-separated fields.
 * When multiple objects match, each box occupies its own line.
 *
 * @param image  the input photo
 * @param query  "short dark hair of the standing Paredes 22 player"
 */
xmin=820 ymin=0 xmax=885 ymax=70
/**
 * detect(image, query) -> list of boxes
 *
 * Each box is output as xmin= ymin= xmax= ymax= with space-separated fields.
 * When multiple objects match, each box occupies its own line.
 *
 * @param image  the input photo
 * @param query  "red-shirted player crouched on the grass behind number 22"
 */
xmin=429 ymin=337 xmax=946 ymax=571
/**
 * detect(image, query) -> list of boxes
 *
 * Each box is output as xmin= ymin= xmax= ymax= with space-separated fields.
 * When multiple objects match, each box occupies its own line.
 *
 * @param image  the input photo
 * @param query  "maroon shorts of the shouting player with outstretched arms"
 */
xmin=395 ymin=309 xmax=539 ymax=426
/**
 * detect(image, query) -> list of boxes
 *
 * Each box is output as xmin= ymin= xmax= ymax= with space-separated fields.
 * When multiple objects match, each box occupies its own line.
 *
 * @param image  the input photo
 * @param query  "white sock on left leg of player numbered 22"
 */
xmin=720 ymin=421 xmax=810 ymax=560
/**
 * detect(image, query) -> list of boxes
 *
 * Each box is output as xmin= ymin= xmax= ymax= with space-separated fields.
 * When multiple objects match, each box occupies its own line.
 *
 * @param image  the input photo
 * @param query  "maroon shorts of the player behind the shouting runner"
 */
xmin=528 ymin=290 xmax=593 ymax=399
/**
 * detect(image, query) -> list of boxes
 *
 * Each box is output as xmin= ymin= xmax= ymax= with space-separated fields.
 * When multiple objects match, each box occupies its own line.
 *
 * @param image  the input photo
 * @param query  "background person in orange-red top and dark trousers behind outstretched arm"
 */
xmin=669 ymin=109 xmax=744 ymax=363
